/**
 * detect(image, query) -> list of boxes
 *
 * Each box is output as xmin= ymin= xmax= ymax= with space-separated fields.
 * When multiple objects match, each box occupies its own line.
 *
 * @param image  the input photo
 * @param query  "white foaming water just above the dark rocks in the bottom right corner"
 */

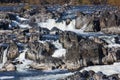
xmin=81 ymin=62 xmax=120 ymax=75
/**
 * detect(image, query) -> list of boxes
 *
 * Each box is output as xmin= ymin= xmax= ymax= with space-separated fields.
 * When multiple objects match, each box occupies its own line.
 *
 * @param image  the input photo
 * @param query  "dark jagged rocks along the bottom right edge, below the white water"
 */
xmin=61 ymin=70 xmax=120 ymax=80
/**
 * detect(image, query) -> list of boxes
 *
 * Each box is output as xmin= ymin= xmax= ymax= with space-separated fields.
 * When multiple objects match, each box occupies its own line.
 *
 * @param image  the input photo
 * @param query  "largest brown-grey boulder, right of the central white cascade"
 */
xmin=66 ymin=39 xmax=104 ymax=67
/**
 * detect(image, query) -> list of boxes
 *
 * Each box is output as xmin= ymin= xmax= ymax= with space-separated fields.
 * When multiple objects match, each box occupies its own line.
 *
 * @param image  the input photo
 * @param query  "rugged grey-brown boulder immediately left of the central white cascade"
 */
xmin=26 ymin=42 xmax=55 ymax=63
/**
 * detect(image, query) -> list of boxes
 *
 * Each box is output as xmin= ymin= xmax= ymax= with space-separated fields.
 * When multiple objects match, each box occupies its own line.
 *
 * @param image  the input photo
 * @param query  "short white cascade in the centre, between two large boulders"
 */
xmin=52 ymin=41 xmax=66 ymax=58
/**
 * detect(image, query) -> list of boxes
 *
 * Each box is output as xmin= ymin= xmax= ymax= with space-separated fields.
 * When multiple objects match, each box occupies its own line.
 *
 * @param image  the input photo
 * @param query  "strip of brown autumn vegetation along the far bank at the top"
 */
xmin=0 ymin=0 xmax=120 ymax=6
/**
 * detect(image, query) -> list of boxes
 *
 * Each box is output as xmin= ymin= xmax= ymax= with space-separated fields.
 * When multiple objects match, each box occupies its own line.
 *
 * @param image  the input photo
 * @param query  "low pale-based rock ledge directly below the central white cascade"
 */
xmin=30 ymin=57 xmax=63 ymax=70
